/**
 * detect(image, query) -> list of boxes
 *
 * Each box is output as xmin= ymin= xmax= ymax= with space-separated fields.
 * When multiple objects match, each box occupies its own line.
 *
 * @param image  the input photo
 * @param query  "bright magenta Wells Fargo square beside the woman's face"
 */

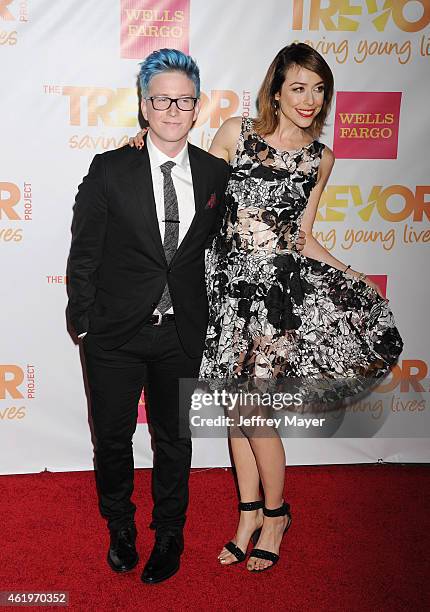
xmin=334 ymin=91 xmax=402 ymax=159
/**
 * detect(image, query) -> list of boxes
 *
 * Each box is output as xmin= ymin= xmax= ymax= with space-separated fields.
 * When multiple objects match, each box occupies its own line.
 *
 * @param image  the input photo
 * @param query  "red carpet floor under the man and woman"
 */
xmin=0 ymin=465 xmax=430 ymax=612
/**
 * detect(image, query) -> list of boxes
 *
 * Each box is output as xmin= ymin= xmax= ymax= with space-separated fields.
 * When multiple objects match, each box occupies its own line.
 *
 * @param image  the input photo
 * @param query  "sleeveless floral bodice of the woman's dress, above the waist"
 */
xmin=223 ymin=118 xmax=324 ymax=254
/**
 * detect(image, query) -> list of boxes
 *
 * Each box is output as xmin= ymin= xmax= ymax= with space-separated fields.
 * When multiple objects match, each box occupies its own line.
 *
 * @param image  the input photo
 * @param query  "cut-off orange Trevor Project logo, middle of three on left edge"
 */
xmin=0 ymin=181 xmax=33 ymax=242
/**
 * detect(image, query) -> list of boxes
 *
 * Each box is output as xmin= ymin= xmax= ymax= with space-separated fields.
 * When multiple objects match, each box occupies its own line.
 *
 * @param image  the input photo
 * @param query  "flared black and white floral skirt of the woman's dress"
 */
xmin=200 ymin=250 xmax=403 ymax=394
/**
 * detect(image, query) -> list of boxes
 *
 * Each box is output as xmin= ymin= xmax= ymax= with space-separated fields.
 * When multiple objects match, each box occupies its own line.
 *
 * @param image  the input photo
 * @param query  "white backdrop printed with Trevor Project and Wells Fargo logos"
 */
xmin=0 ymin=0 xmax=430 ymax=474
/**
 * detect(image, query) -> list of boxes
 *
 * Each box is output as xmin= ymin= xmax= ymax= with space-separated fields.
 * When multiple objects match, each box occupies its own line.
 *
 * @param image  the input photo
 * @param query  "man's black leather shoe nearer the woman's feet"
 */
xmin=142 ymin=533 xmax=184 ymax=584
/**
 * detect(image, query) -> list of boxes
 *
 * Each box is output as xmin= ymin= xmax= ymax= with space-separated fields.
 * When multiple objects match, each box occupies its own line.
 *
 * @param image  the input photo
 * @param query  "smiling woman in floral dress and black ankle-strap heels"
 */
xmin=200 ymin=44 xmax=402 ymax=571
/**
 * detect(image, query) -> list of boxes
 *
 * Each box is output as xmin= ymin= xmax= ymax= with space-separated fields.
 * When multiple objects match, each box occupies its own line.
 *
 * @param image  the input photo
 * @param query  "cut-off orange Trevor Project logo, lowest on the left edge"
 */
xmin=0 ymin=364 xmax=36 ymax=422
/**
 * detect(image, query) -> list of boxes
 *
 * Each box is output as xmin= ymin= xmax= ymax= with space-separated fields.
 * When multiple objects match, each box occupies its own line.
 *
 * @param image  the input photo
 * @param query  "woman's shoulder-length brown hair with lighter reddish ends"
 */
xmin=254 ymin=43 xmax=334 ymax=137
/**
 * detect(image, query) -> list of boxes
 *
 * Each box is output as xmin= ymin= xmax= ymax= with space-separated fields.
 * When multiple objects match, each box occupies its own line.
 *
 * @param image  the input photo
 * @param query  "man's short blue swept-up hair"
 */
xmin=139 ymin=49 xmax=200 ymax=98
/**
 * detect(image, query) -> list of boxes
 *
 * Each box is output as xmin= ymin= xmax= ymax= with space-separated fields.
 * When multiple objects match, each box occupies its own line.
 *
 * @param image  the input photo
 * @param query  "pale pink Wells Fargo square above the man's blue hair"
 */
xmin=121 ymin=0 xmax=190 ymax=59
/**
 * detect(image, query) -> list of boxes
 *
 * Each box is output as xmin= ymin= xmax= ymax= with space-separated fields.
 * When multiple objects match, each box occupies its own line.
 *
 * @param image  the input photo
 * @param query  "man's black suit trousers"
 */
xmin=83 ymin=320 xmax=200 ymax=532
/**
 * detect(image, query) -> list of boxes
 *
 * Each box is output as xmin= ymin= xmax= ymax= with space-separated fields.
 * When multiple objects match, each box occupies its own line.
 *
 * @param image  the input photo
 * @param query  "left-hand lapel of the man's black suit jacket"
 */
xmin=127 ymin=147 xmax=165 ymax=260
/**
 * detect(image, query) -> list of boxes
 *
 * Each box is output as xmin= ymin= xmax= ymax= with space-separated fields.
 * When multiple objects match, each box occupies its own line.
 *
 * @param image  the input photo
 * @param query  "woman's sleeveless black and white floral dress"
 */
xmin=200 ymin=119 xmax=402 ymax=402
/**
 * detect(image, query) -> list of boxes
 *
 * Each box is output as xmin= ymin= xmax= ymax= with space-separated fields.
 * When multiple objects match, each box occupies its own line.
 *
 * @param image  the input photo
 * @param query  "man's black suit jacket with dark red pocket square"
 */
xmin=68 ymin=144 xmax=228 ymax=357
